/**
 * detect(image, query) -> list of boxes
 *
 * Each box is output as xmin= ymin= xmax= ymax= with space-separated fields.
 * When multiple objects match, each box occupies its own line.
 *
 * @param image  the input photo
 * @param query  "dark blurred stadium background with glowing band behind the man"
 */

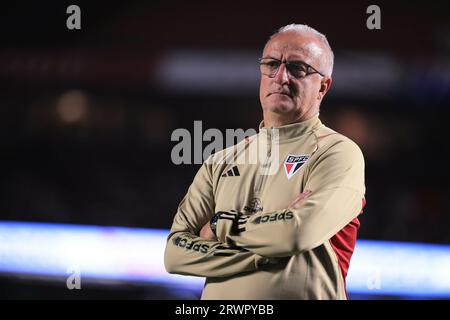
xmin=0 ymin=0 xmax=450 ymax=299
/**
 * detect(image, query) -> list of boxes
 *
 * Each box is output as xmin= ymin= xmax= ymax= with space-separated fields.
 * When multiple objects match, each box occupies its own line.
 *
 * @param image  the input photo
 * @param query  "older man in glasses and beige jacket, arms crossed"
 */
xmin=165 ymin=24 xmax=365 ymax=299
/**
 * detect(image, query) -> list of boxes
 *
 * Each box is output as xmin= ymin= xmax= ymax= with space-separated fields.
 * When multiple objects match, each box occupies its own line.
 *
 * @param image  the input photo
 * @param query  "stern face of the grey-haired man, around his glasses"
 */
xmin=259 ymin=31 xmax=331 ymax=120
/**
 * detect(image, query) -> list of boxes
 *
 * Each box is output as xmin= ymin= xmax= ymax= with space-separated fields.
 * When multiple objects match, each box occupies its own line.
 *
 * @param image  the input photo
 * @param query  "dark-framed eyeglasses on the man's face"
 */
xmin=259 ymin=58 xmax=325 ymax=79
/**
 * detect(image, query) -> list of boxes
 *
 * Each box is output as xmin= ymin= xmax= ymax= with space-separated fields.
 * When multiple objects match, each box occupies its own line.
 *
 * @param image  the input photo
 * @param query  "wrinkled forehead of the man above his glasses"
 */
xmin=263 ymin=32 xmax=323 ymax=63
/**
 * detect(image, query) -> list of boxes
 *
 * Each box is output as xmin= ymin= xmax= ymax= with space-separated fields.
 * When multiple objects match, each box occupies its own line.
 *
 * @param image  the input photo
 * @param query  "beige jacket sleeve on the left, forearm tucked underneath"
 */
xmin=164 ymin=159 xmax=270 ymax=277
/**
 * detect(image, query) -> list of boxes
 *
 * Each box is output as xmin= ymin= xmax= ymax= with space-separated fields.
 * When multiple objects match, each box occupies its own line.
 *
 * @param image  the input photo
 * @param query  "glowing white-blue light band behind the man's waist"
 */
xmin=0 ymin=221 xmax=450 ymax=298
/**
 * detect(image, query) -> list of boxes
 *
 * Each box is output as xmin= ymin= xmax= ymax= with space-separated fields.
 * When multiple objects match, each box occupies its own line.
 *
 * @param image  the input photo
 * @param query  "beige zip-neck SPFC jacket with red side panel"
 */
xmin=164 ymin=116 xmax=365 ymax=299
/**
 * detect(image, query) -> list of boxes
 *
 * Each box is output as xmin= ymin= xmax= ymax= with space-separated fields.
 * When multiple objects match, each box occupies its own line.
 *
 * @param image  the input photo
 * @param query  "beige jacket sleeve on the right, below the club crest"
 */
xmin=217 ymin=140 xmax=365 ymax=257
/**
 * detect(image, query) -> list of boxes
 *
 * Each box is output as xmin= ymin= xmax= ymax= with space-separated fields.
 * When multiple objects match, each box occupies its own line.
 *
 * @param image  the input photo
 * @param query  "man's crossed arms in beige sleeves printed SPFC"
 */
xmin=164 ymin=141 xmax=364 ymax=277
